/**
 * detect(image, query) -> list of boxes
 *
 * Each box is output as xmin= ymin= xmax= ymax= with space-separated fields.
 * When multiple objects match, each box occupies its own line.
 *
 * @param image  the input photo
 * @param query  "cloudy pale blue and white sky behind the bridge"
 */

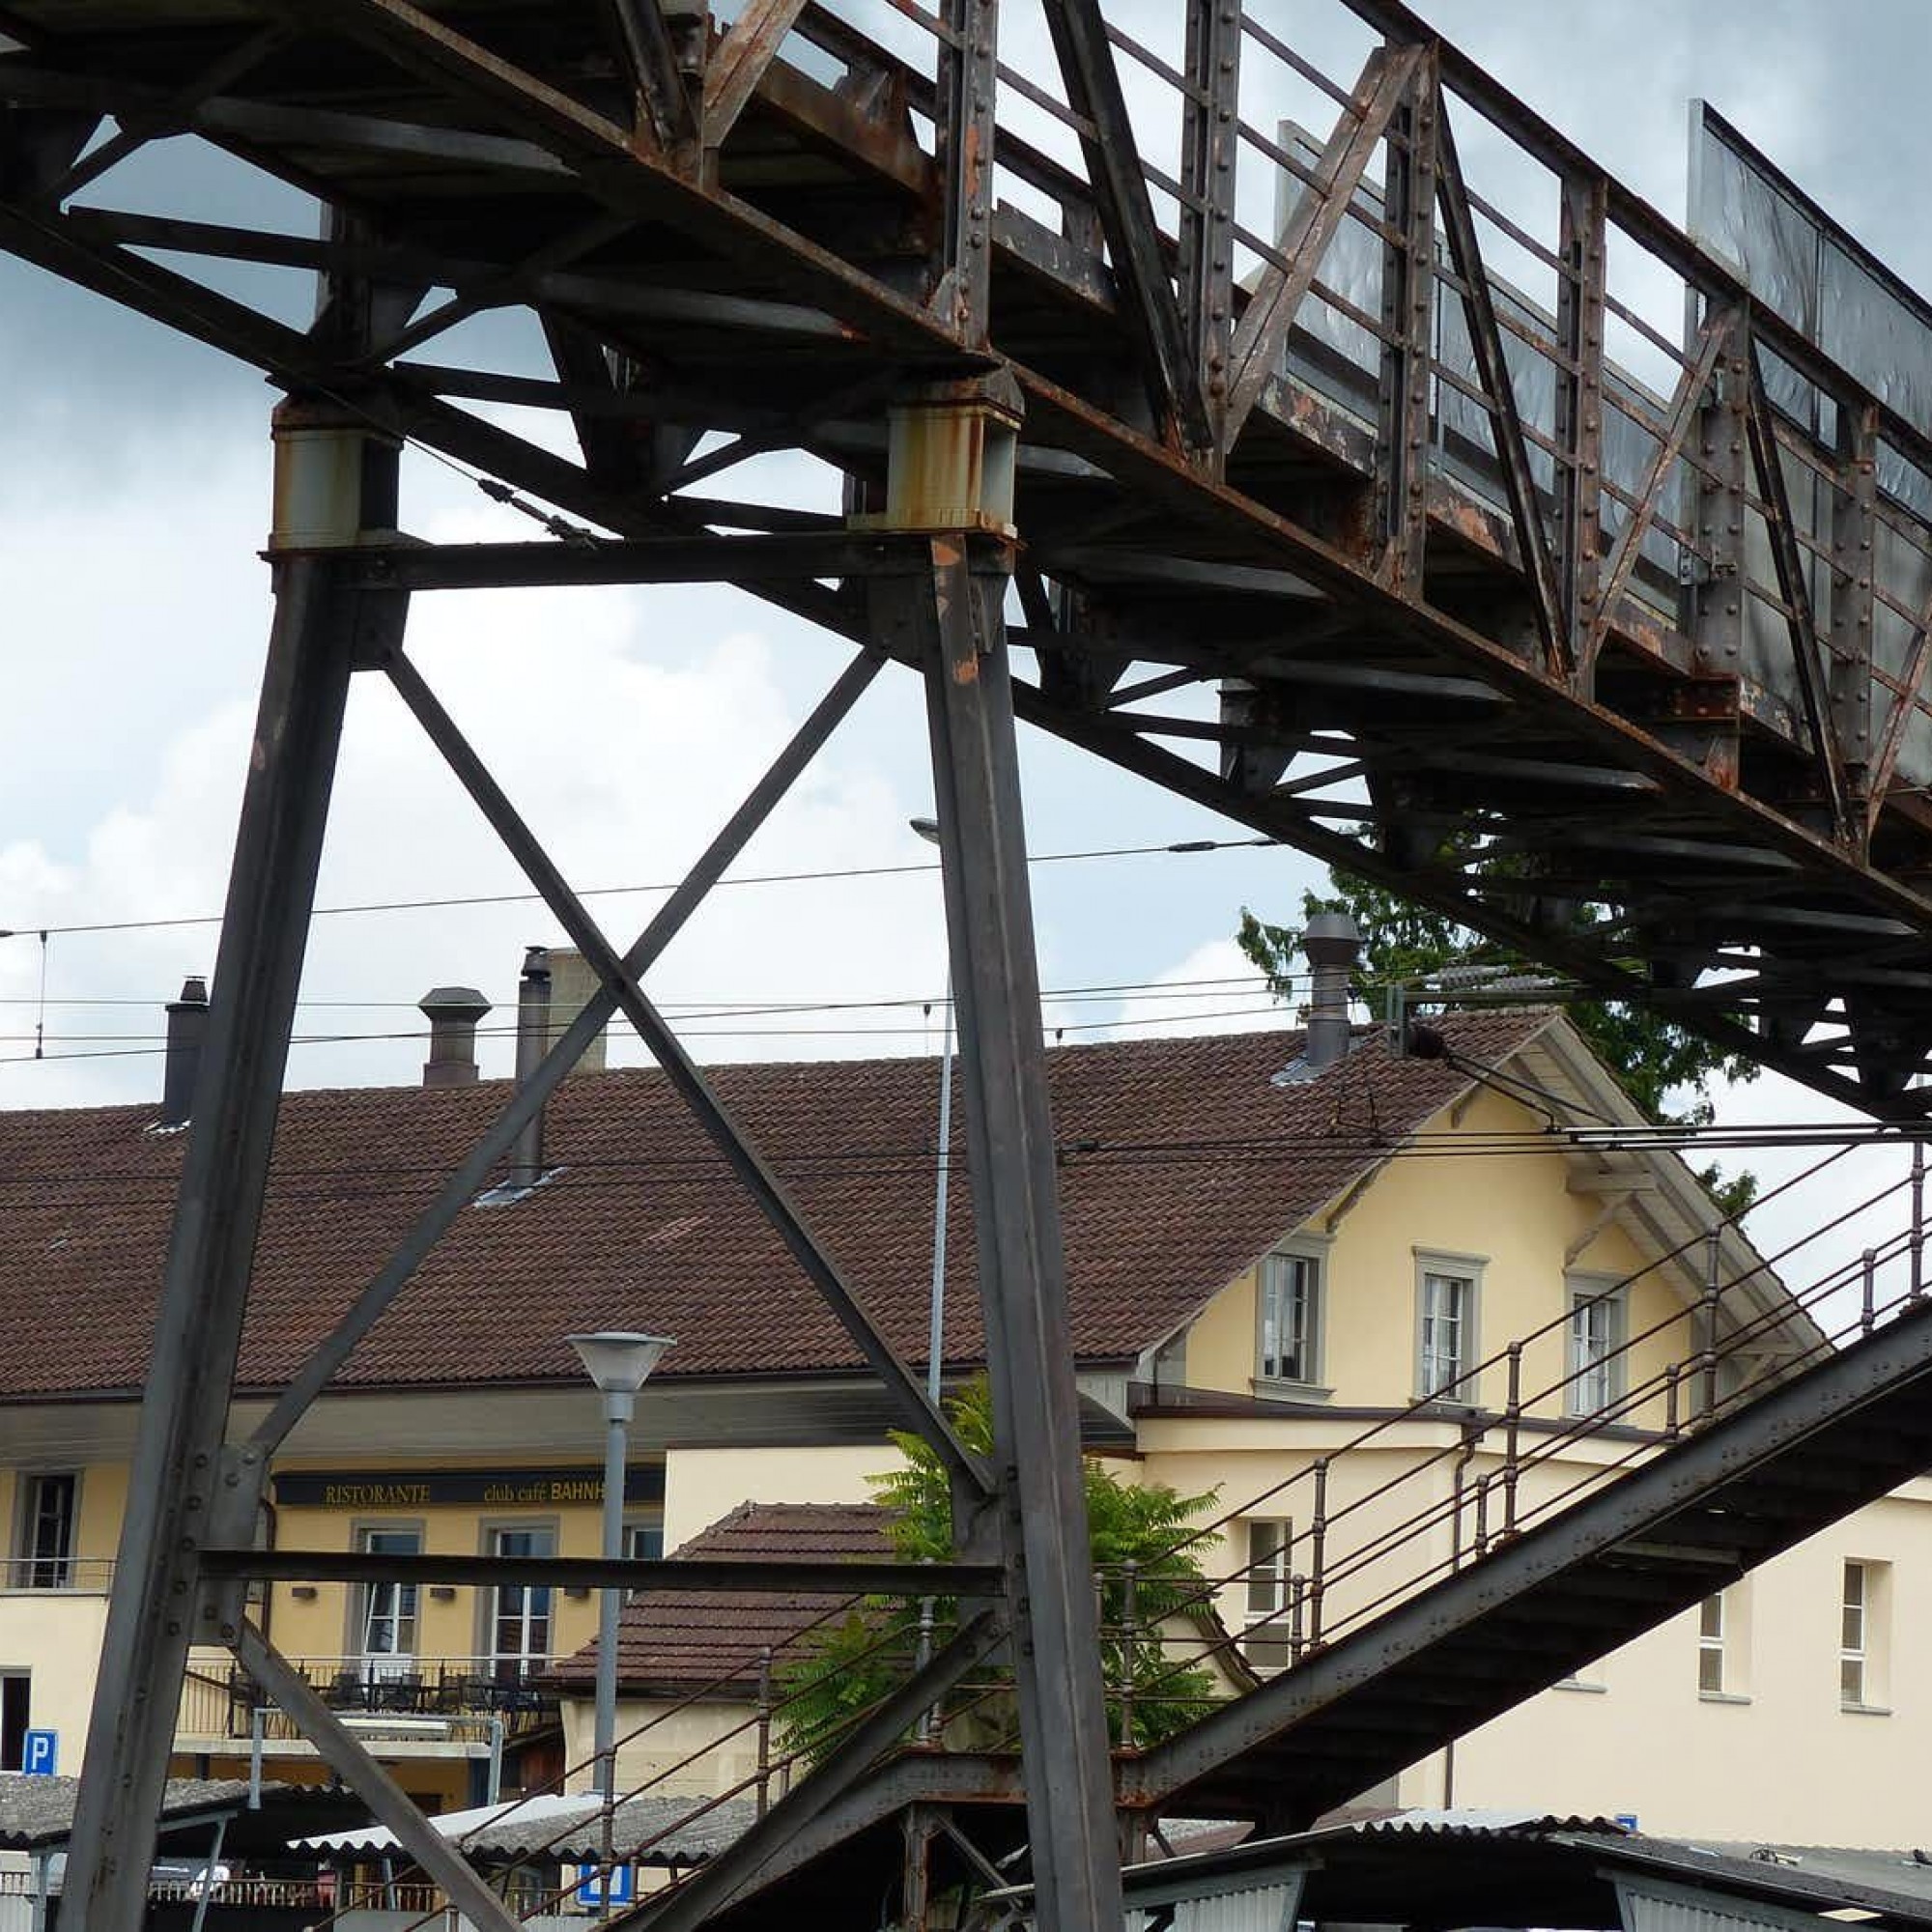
xmin=0 ymin=0 xmax=1932 ymax=1314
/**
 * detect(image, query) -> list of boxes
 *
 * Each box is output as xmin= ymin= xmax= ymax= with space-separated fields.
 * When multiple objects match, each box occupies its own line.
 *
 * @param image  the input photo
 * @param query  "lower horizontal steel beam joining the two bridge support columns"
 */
xmin=201 ymin=1546 xmax=1005 ymax=1598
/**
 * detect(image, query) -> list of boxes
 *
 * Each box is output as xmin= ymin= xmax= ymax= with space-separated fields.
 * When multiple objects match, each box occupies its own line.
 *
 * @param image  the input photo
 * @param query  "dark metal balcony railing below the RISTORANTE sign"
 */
xmin=176 ymin=1658 xmax=558 ymax=1743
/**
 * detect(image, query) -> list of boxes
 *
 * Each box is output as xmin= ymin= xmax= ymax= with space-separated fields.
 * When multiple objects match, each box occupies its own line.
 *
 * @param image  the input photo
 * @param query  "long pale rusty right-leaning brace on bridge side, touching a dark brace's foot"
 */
xmin=1223 ymin=46 xmax=1434 ymax=448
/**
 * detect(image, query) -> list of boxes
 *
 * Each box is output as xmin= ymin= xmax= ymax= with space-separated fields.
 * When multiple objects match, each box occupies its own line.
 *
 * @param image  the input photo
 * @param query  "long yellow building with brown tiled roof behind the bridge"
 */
xmin=0 ymin=1010 xmax=1901 ymax=1835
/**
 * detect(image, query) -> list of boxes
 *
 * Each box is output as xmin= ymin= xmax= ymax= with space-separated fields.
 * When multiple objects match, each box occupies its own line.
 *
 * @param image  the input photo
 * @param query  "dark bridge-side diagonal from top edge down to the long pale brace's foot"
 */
xmin=1045 ymin=0 xmax=1213 ymax=450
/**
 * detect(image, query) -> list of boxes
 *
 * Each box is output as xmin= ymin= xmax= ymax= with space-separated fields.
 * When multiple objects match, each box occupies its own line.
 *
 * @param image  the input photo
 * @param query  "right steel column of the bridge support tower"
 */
xmin=908 ymin=537 xmax=1121 ymax=1932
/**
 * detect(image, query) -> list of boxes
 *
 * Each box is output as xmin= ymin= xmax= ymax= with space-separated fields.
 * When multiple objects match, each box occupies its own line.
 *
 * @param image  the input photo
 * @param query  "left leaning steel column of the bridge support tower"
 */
xmin=66 ymin=437 xmax=402 ymax=1932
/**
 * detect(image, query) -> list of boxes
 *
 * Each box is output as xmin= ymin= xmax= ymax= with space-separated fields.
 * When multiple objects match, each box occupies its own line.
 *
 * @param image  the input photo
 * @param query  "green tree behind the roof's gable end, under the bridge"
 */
xmin=1235 ymin=869 xmax=1758 ymax=1215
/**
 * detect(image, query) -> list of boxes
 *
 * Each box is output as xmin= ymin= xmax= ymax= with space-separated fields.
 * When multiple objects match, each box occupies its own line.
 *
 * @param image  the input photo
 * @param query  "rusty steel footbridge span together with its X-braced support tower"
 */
xmin=11 ymin=0 xmax=1932 ymax=1932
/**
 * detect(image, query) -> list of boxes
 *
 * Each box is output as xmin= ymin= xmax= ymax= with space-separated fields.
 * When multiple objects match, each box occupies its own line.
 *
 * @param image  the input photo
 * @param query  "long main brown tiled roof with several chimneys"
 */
xmin=0 ymin=1012 xmax=1551 ymax=1401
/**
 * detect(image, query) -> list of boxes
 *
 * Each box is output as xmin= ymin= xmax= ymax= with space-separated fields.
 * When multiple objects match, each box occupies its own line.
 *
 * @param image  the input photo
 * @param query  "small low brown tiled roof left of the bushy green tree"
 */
xmin=551 ymin=1503 xmax=893 ymax=1692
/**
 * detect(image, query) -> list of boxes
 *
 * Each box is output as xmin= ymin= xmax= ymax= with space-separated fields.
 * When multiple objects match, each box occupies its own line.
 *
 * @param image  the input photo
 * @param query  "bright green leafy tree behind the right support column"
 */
xmin=779 ymin=1376 xmax=1215 ymax=1760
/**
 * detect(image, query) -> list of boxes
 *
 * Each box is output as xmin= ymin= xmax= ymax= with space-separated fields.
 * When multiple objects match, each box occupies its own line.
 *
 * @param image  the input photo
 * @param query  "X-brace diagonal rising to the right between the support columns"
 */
xmin=249 ymin=651 xmax=883 ymax=1466
